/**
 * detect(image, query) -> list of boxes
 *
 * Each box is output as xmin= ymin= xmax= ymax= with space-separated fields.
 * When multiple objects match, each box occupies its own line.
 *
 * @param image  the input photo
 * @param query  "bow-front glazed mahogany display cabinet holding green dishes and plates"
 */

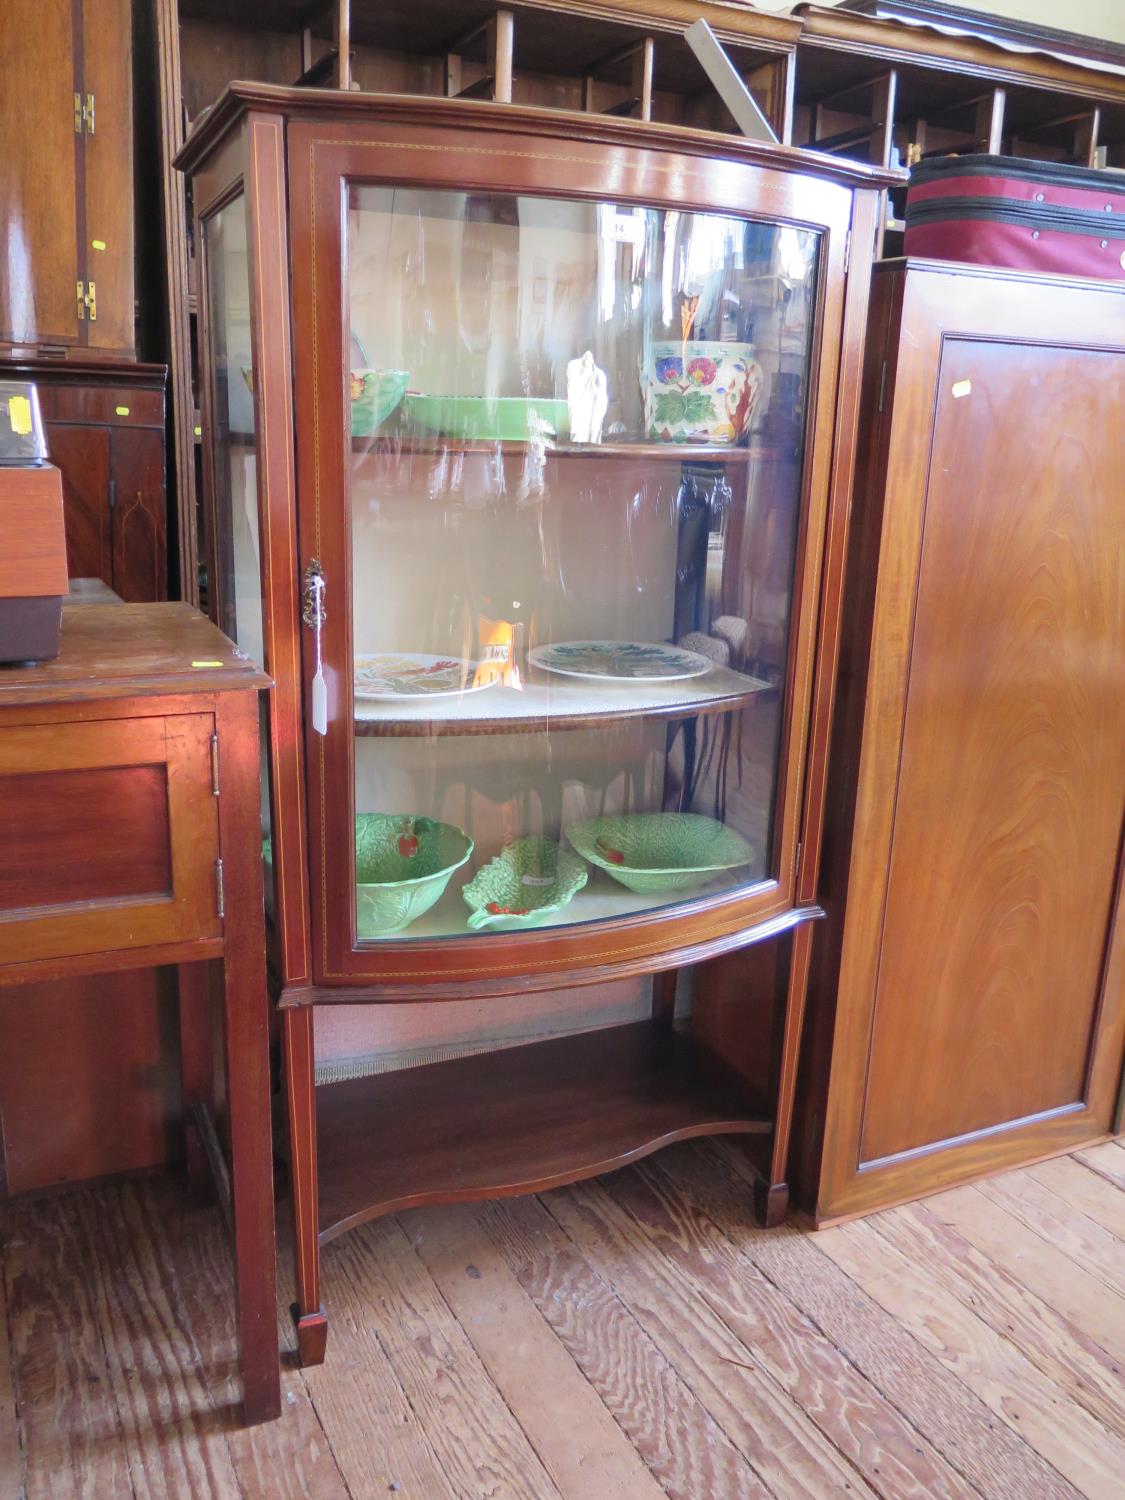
xmin=179 ymin=84 xmax=890 ymax=1362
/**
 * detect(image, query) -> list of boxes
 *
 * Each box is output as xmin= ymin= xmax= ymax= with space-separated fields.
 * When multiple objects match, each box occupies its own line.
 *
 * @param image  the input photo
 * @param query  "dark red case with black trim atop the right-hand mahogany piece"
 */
xmin=903 ymin=156 xmax=1125 ymax=281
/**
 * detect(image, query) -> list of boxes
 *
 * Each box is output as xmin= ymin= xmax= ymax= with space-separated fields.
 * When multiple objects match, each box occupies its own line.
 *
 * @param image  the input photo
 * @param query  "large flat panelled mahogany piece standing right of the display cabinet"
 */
xmin=800 ymin=261 xmax=1125 ymax=1221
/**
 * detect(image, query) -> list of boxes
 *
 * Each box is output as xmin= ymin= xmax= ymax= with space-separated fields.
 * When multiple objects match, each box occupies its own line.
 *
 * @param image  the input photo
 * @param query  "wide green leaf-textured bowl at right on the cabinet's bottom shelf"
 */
xmin=567 ymin=813 xmax=755 ymax=896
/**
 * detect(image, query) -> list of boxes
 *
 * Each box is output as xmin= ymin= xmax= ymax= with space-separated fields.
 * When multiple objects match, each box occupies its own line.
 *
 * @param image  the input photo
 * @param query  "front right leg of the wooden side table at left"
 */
xmin=218 ymin=693 xmax=281 ymax=1422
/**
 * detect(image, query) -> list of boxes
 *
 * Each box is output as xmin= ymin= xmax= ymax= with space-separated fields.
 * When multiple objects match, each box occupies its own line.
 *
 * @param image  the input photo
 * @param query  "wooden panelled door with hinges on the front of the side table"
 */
xmin=0 ymin=714 xmax=222 ymax=965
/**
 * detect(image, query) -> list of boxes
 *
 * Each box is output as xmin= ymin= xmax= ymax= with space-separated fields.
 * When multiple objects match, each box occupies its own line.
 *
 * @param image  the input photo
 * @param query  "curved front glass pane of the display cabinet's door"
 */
xmin=344 ymin=185 xmax=819 ymax=942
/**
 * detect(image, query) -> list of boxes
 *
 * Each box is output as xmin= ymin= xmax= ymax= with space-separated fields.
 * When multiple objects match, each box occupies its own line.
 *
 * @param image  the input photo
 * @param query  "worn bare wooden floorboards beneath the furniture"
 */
xmin=0 ymin=1142 xmax=1125 ymax=1500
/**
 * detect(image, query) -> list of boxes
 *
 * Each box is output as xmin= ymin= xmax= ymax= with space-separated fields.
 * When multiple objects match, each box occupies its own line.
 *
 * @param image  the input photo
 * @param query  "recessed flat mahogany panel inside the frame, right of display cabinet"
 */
xmin=860 ymin=338 xmax=1125 ymax=1163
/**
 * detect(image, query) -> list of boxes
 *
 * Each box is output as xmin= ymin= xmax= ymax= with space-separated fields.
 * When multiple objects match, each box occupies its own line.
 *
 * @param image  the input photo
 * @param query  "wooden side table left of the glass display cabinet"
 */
xmin=0 ymin=603 xmax=281 ymax=1422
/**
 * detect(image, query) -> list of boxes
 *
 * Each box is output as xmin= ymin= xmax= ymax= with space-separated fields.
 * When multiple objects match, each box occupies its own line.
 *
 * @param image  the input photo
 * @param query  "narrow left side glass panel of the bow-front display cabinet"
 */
xmin=203 ymin=197 xmax=275 ymax=911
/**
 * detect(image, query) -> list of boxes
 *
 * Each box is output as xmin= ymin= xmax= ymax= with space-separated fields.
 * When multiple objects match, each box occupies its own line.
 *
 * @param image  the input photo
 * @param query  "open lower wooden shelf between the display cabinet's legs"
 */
xmin=317 ymin=1022 xmax=773 ymax=1245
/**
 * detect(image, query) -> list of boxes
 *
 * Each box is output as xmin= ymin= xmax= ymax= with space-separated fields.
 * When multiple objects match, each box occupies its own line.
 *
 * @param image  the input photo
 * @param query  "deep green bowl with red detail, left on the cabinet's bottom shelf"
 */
xmin=356 ymin=813 xmax=473 ymax=938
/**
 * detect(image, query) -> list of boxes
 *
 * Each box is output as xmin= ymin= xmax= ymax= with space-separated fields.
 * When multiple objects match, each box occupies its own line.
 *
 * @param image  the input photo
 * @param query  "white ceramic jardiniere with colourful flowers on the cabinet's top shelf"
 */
xmin=641 ymin=339 xmax=762 ymax=443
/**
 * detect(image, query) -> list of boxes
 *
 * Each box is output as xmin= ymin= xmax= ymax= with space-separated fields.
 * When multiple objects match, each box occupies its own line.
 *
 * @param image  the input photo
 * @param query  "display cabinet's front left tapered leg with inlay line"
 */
xmin=282 ymin=1005 xmax=329 ymax=1365
